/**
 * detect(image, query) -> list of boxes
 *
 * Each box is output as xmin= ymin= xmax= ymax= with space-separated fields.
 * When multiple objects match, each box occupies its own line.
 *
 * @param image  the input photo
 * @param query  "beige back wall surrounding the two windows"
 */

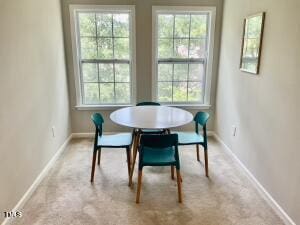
xmin=62 ymin=0 xmax=223 ymax=133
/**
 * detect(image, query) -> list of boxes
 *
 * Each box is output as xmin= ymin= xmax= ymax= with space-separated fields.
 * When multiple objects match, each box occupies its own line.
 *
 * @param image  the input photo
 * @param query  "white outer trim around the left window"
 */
xmin=69 ymin=5 xmax=136 ymax=110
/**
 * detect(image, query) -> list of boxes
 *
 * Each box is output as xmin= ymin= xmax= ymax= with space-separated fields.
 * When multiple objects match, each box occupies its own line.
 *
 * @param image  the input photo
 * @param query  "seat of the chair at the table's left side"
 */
xmin=98 ymin=133 xmax=132 ymax=148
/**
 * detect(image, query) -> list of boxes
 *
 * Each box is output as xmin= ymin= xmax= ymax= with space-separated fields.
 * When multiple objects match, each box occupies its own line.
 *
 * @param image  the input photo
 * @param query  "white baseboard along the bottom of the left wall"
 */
xmin=1 ymin=134 xmax=72 ymax=225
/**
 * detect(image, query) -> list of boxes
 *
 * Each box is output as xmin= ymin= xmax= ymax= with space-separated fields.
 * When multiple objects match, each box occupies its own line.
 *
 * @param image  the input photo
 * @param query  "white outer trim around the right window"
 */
xmin=152 ymin=6 xmax=216 ymax=109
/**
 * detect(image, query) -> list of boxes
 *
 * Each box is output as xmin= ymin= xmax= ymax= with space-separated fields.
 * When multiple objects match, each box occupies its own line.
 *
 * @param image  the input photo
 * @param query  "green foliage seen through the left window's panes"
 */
xmin=77 ymin=12 xmax=131 ymax=105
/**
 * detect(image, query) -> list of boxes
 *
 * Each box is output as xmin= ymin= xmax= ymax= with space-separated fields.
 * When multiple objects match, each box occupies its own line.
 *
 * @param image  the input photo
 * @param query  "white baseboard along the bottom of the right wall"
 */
xmin=212 ymin=132 xmax=296 ymax=225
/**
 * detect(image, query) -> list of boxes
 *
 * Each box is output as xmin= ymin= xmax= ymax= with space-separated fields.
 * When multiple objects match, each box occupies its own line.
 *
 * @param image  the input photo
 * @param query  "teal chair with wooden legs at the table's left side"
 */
xmin=91 ymin=113 xmax=132 ymax=182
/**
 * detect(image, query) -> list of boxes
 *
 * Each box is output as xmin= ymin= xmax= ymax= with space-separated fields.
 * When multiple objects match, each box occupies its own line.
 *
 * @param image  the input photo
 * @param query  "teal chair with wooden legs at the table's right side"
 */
xmin=172 ymin=112 xmax=209 ymax=177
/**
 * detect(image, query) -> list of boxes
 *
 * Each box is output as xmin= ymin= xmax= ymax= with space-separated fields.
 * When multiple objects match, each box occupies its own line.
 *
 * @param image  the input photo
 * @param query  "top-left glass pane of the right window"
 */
xmin=158 ymin=15 xmax=174 ymax=38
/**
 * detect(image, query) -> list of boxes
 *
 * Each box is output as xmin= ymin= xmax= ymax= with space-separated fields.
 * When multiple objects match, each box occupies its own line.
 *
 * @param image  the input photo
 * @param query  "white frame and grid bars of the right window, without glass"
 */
xmin=152 ymin=6 xmax=216 ymax=106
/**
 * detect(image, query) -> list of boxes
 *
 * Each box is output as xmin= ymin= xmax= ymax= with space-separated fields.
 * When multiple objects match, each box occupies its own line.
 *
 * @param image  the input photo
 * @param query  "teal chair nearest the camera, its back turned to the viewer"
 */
xmin=136 ymin=134 xmax=182 ymax=203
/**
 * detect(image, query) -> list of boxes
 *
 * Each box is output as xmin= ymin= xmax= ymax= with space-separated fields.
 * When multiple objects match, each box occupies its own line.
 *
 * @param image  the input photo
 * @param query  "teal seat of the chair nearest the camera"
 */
xmin=142 ymin=147 xmax=176 ymax=166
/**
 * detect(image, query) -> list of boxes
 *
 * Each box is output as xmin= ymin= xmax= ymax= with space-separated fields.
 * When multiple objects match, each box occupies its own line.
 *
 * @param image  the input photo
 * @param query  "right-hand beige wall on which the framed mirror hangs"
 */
xmin=215 ymin=0 xmax=300 ymax=224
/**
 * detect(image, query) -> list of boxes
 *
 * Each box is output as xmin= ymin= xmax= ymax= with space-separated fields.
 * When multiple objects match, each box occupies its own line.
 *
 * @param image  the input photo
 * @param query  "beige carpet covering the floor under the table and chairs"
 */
xmin=11 ymin=138 xmax=283 ymax=225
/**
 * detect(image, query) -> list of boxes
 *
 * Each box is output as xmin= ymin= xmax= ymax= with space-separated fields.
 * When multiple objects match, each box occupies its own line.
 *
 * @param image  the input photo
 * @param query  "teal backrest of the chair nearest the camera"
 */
xmin=139 ymin=134 xmax=180 ymax=169
